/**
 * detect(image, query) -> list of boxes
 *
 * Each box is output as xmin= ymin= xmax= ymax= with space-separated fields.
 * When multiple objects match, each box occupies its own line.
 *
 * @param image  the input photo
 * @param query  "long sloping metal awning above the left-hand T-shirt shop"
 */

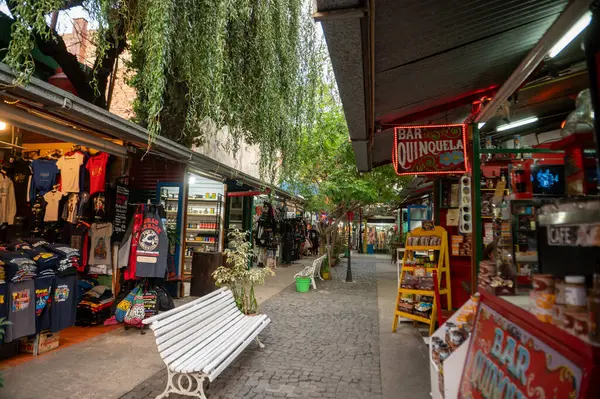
xmin=0 ymin=63 xmax=304 ymax=203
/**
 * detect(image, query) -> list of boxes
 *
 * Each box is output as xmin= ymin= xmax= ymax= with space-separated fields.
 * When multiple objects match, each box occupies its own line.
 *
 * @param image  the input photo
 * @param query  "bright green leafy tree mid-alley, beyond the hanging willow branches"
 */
xmin=284 ymin=73 xmax=408 ymax=259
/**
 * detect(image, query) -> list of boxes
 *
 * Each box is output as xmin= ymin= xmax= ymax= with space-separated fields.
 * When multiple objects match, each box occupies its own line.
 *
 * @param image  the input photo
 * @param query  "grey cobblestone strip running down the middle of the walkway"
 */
xmin=122 ymin=258 xmax=381 ymax=399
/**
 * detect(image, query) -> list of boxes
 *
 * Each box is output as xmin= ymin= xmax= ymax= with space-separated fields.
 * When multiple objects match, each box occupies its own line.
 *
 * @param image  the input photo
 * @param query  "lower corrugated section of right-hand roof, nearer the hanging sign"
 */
xmin=375 ymin=16 xmax=555 ymax=121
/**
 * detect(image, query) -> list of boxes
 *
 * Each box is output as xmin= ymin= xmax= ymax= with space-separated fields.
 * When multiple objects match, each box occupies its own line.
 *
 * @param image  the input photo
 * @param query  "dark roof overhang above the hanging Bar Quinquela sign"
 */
xmin=314 ymin=0 xmax=590 ymax=171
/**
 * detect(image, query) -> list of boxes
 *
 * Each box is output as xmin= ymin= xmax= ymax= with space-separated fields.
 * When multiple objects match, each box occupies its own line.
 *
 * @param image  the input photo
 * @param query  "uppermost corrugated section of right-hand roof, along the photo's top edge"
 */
xmin=375 ymin=0 xmax=568 ymax=72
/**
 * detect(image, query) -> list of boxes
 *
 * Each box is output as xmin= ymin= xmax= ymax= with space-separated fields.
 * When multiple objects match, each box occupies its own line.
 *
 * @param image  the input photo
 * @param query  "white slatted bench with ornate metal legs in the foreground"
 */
xmin=144 ymin=288 xmax=271 ymax=399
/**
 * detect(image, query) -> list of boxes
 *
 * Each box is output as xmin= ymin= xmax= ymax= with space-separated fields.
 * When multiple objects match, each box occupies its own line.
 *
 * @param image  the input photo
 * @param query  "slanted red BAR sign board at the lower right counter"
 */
xmin=459 ymin=294 xmax=591 ymax=399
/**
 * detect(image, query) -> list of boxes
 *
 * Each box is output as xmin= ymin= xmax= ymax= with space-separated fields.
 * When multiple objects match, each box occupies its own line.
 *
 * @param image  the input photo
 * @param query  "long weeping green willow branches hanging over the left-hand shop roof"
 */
xmin=4 ymin=0 xmax=323 ymax=182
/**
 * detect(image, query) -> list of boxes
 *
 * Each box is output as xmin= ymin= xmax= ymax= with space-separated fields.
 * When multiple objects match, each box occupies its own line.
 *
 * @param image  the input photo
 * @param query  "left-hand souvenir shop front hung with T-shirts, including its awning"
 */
xmin=0 ymin=64 xmax=300 ymax=361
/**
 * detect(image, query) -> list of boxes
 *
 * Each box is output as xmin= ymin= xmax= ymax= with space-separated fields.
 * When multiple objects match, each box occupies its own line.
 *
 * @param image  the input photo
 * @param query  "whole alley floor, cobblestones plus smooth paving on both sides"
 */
xmin=0 ymin=254 xmax=430 ymax=399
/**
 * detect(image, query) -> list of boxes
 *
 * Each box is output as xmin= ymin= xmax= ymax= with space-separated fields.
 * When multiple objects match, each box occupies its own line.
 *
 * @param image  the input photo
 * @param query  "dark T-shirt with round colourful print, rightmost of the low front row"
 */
xmin=50 ymin=276 xmax=77 ymax=332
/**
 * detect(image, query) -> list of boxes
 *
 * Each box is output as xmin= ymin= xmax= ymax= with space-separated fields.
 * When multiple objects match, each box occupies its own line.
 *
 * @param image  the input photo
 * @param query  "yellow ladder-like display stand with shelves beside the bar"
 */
xmin=392 ymin=226 xmax=452 ymax=335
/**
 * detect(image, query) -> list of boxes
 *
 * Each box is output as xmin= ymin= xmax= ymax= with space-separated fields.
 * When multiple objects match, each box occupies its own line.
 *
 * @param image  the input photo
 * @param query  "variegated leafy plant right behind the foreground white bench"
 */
xmin=212 ymin=229 xmax=275 ymax=315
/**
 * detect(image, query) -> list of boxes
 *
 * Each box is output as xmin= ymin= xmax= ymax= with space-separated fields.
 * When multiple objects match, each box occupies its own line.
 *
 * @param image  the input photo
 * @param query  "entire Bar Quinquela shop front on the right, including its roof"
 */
xmin=317 ymin=0 xmax=600 ymax=398
